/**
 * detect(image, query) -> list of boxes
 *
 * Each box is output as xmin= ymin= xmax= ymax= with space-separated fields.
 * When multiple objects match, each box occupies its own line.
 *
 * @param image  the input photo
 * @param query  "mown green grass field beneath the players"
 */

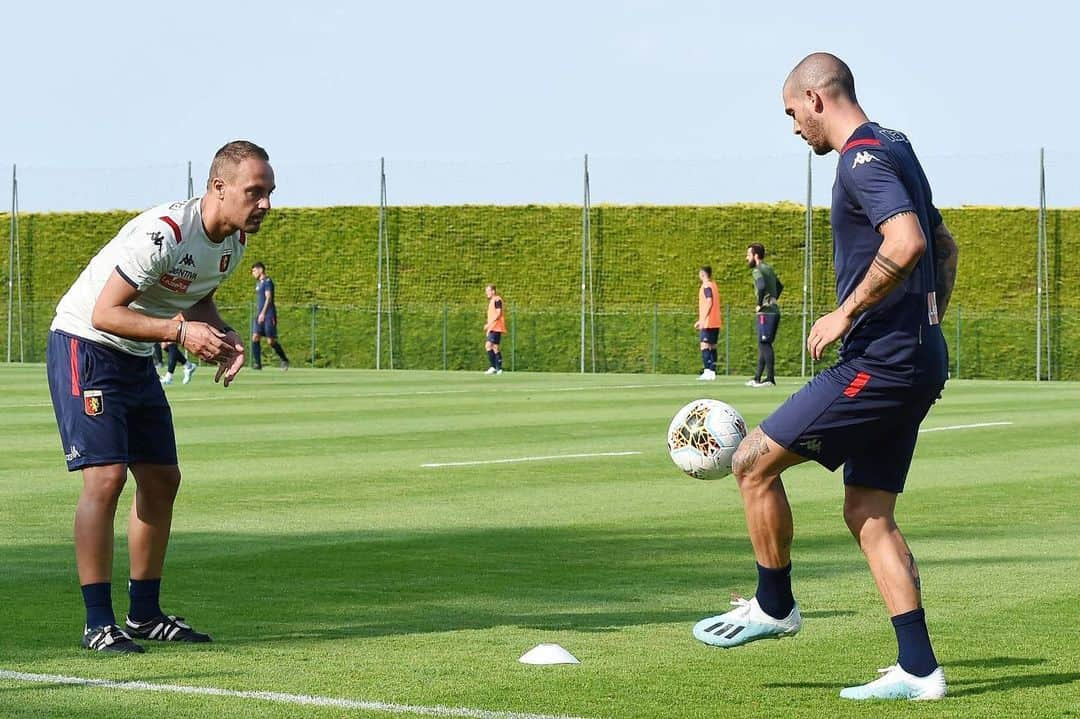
xmin=0 ymin=366 xmax=1080 ymax=719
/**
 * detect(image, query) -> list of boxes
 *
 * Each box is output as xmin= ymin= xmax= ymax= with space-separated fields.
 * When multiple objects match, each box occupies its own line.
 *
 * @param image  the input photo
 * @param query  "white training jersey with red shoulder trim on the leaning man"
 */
xmin=52 ymin=198 xmax=247 ymax=356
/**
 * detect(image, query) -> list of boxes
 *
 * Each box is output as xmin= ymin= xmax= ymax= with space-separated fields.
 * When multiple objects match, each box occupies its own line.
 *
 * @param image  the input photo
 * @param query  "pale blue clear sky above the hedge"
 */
xmin=0 ymin=0 xmax=1080 ymax=211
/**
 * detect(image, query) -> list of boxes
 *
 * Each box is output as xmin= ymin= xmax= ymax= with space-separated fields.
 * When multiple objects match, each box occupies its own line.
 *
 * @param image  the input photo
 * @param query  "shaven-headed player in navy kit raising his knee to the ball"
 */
xmin=694 ymin=53 xmax=957 ymax=700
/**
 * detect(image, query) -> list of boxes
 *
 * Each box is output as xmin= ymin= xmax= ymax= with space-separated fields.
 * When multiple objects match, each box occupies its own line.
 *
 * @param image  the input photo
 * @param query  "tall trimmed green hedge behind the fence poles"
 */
xmin=0 ymin=204 xmax=1080 ymax=379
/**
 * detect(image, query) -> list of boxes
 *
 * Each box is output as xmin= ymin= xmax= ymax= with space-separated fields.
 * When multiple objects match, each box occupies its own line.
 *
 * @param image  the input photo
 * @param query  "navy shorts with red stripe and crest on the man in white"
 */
xmin=45 ymin=331 xmax=176 ymax=472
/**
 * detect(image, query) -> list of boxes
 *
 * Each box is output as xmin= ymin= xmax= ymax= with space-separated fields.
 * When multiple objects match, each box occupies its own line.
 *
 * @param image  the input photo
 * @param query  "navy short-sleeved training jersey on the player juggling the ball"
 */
xmin=831 ymin=122 xmax=942 ymax=354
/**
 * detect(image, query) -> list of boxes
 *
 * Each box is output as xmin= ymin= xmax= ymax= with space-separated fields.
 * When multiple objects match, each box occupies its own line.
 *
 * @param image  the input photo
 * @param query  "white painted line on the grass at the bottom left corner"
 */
xmin=0 ymin=669 xmax=591 ymax=719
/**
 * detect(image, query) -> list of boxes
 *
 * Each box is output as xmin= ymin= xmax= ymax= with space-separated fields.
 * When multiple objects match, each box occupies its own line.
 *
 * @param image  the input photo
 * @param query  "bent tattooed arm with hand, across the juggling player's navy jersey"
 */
xmin=807 ymin=212 xmax=927 ymax=360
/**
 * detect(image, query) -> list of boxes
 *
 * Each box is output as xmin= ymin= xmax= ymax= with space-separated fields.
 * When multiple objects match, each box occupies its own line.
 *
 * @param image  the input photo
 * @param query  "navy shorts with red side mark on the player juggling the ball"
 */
xmin=761 ymin=360 xmax=944 ymax=494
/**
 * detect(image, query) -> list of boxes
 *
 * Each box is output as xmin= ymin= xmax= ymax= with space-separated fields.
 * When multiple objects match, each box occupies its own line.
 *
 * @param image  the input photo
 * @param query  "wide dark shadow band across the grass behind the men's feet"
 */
xmin=0 ymin=520 xmax=865 ymax=657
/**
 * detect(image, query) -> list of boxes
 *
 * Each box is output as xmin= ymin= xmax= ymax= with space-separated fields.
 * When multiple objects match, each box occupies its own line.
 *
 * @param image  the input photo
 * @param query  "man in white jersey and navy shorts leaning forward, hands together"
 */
xmin=46 ymin=140 xmax=274 ymax=652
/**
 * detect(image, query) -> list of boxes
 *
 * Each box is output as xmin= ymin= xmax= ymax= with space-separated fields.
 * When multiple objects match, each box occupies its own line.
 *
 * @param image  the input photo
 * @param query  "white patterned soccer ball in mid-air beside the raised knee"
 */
xmin=667 ymin=399 xmax=746 ymax=479
